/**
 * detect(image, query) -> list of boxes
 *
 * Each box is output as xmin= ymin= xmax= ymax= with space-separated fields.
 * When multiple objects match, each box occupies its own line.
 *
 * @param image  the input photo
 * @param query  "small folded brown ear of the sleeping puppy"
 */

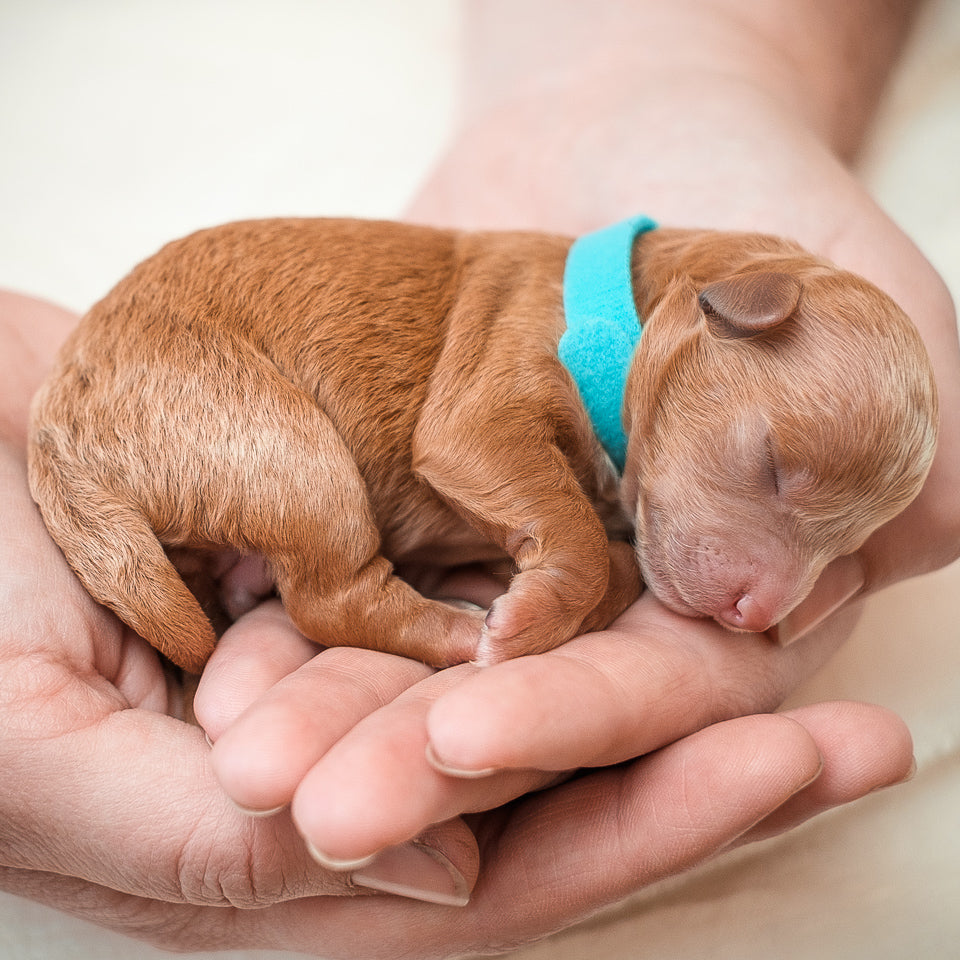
xmin=699 ymin=272 xmax=802 ymax=339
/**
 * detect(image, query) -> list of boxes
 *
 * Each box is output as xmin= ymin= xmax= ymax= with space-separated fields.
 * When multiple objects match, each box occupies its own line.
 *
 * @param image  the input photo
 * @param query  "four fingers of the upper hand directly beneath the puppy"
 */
xmin=195 ymin=568 xmax=884 ymax=864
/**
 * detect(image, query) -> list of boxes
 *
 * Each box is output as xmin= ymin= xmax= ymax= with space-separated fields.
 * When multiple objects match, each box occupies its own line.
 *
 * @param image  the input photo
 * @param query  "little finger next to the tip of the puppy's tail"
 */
xmin=193 ymin=600 xmax=320 ymax=742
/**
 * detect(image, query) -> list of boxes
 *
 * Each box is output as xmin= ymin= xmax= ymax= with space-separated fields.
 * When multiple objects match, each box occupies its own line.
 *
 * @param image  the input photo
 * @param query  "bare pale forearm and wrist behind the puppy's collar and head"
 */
xmin=409 ymin=0 xmax=918 ymax=237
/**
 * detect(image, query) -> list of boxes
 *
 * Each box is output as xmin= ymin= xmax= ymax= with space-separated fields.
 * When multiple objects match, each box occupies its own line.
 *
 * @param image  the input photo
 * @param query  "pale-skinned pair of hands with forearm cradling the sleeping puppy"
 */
xmin=0 ymin=0 xmax=960 ymax=957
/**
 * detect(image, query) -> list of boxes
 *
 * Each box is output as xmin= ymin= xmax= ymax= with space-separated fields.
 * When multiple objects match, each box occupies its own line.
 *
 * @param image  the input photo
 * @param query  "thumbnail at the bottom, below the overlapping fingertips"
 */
xmin=351 ymin=840 xmax=470 ymax=907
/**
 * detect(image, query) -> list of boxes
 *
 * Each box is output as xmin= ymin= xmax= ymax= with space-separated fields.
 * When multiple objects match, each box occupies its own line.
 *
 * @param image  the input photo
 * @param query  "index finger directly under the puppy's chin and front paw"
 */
xmin=427 ymin=594 xmax=856 ymax=776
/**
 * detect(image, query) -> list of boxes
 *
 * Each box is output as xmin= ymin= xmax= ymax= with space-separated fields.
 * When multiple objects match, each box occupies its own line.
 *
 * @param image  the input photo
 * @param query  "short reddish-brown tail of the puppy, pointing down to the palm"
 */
xmin=29 ymin=443 xmax=217 ymax=673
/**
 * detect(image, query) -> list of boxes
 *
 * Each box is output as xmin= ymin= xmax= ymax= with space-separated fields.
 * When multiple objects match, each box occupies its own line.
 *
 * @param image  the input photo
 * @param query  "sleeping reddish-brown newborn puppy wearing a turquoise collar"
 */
xmin=30 ymin=220 xmax=937 ymax=671
